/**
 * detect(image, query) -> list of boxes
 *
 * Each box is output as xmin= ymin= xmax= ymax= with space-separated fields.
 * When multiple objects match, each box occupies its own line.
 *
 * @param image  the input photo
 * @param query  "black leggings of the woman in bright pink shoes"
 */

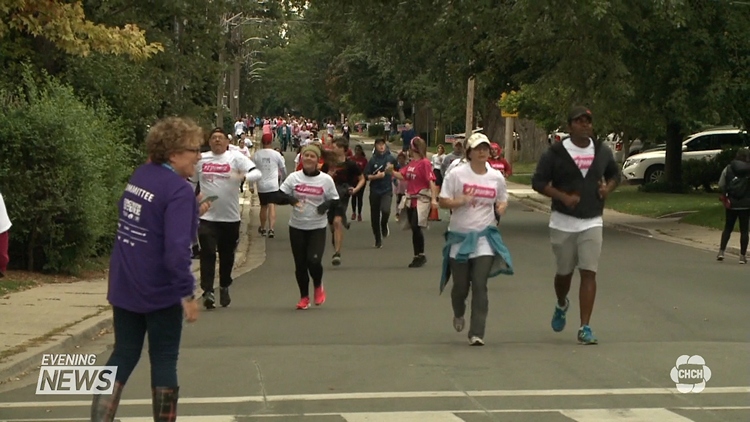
xmin=289 ymin=227 xmax=326 ymax=297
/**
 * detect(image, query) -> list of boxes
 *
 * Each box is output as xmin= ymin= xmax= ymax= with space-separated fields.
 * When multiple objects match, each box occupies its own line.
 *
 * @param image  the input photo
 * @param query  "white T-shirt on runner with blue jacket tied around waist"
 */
xmin=440 ymin=166 xmax=508 ymax=259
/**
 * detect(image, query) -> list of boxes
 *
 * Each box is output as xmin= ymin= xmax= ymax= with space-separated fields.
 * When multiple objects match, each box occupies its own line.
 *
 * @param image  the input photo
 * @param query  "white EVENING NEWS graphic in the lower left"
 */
xmin=36 ymin=354 xmax=117 ymax=395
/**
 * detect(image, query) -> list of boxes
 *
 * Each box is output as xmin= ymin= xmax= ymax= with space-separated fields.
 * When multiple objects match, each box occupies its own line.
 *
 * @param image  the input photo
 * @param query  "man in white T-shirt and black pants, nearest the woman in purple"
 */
xmin=191 ymin=128 xmax=262 ymax=309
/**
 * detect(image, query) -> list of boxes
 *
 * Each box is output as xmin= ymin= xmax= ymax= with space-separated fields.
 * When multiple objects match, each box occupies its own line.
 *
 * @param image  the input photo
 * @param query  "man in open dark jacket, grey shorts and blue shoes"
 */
xmin=531 ymin=106 xmax=621 ymax=344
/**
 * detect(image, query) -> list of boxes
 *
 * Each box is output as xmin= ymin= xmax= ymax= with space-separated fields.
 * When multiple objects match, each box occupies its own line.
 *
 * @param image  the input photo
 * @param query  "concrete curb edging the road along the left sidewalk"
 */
xmin=0 ymin=190 xmax=265 ymax=384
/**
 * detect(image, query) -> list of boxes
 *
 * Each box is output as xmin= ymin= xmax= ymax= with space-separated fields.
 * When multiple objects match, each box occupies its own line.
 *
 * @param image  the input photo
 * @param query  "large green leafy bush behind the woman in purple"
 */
xmin=0 ymin=72 xmax=136 ymax=274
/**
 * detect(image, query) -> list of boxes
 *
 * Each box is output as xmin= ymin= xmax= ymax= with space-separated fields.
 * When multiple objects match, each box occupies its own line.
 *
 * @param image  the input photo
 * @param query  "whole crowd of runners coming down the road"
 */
xmin=191 ymin=108 xmax=619 ymax=345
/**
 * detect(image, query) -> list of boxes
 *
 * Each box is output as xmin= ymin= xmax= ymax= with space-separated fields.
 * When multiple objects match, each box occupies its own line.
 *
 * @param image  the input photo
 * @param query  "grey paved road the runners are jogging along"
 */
xmin=0 ymin=143 xmax=750 ymax=422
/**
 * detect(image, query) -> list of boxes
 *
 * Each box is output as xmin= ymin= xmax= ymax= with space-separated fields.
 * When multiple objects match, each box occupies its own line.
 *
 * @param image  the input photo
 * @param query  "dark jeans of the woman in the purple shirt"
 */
xmin=107 ymin=304 xmax=182 ymax=387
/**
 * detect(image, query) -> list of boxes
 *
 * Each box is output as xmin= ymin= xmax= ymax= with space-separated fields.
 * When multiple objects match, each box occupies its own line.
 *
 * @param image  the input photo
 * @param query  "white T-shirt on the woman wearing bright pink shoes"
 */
xmin=281 ymin=170 xmax=339 ymax=230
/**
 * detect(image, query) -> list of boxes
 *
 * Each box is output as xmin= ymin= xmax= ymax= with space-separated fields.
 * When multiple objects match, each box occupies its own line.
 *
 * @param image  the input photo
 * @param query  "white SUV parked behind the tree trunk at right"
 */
xmin=622 ymin=129 xmax=748 ymax=183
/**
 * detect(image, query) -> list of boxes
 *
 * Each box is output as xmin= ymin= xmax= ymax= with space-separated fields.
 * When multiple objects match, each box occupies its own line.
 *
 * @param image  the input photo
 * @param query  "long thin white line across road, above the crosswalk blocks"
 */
xmin=0 ymin=386 xmax=750 ymax=409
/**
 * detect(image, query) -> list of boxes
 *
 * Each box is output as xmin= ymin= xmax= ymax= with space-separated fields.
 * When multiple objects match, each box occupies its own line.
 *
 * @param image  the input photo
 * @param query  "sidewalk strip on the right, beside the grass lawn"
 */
xmin=508 ymin=182 xmax=740 ymax=255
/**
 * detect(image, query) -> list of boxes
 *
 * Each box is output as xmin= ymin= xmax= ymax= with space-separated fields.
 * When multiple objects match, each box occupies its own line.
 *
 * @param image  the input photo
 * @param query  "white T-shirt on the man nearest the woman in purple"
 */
xmin=192 ymin=150 xmax=255 ymax=222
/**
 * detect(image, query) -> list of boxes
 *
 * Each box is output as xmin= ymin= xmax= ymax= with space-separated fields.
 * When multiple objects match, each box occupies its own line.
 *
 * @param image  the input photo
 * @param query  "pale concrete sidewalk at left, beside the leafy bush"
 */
xmin=0 ymin=189 xmax=265 ymax=384
